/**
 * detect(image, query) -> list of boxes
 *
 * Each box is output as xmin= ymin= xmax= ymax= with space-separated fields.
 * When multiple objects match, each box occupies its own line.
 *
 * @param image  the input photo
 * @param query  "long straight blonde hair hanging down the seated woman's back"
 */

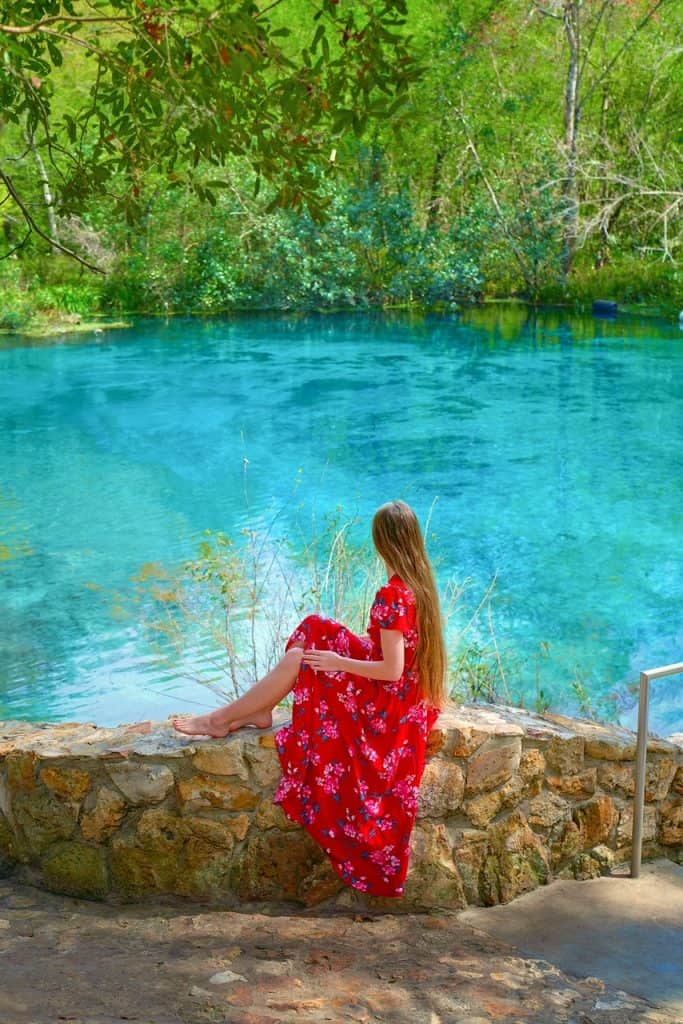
xmin=373 ymin=502 xmax=447 ymax=708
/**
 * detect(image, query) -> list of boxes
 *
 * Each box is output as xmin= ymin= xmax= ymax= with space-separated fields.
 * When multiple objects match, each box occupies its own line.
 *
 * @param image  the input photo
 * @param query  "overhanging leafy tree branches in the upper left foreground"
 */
xmin=0 ymin=0 xmax=417 ymax=224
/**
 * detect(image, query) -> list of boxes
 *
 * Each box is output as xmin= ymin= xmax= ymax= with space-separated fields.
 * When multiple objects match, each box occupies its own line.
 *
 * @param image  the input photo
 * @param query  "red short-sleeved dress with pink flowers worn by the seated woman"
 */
xmin=274 ymin=575 xmax=439 ymax=896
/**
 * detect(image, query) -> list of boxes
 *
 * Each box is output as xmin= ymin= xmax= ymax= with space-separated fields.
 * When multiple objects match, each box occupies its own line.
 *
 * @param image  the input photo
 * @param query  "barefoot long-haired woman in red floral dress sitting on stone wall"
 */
xmin=173 ymin=502 xmax=446 ymax=896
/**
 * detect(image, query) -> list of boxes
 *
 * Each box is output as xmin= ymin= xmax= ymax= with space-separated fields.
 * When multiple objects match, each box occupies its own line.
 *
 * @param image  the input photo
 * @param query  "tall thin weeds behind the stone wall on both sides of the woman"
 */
xmin=129 ymin=495 xmax=514 ymax=702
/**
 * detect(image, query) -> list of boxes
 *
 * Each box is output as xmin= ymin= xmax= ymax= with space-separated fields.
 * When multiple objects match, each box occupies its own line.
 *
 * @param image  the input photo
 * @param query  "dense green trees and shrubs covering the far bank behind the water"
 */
xmin=0 ymin=0 xmax=683 ymax=330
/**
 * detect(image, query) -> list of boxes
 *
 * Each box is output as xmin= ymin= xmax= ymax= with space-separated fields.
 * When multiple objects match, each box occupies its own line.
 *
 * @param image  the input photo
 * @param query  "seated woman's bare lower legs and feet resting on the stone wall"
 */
xmin=172 ymin=647 xmax=303 ymax=736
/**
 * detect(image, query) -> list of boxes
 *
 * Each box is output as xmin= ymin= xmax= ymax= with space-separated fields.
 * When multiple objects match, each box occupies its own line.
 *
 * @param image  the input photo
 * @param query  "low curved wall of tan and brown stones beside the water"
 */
xmin=0 ymin=706 xmax=683 ymax=910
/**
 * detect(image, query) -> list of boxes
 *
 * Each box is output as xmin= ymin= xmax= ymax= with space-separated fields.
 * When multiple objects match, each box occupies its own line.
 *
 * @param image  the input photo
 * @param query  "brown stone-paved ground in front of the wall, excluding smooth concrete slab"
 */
xmin=0 ymin=880 xmax=680 ymax=1024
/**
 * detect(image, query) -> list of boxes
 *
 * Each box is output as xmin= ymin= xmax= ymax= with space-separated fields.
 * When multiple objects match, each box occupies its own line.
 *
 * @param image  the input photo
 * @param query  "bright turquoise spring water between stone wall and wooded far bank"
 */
xmin=0 ymin=307 xmax=683 ymax=732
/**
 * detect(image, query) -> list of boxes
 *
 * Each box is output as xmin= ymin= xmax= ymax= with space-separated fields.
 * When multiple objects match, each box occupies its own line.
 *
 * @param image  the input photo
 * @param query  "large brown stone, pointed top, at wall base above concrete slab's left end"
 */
xmin=481 ymin=810 xmax=550 ymax=906
